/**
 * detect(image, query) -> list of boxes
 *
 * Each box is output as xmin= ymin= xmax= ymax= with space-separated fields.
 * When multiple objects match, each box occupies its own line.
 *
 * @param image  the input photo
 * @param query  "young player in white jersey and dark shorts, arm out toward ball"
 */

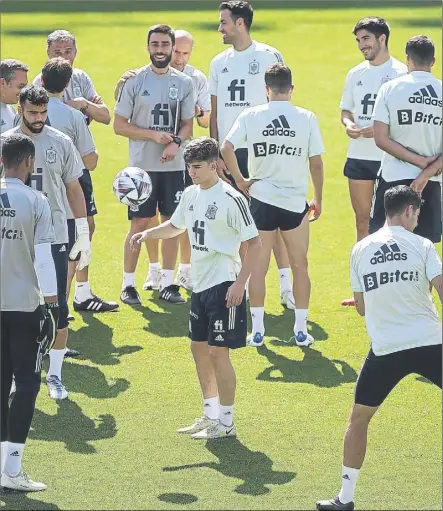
xmin=131 ymin=137 xmax=261 ymax=439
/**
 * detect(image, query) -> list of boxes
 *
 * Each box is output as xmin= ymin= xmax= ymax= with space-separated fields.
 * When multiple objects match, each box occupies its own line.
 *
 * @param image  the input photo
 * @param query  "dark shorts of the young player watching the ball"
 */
xmin=189 ymin=282 xmax=247 ymax=349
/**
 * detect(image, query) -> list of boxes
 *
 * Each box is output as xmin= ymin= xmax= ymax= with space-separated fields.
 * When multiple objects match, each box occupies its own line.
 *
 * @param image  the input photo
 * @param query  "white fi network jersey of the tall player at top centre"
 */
xmin=209 ymin=41 xmax=283 ymax=144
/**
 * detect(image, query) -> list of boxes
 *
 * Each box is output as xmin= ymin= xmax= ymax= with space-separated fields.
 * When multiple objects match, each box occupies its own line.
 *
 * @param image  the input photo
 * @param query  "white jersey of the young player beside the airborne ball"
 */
xmin=171 ymin=179 xmax=258 ymax=293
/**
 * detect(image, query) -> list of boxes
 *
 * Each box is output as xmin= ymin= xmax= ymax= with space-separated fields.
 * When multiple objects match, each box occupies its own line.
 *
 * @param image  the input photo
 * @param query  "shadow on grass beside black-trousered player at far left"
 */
xmin=29 ymin=399 xmax=117 ymax=454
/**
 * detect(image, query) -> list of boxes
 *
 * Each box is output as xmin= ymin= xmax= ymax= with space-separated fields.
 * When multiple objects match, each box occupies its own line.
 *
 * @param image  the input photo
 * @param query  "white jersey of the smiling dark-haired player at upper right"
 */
xmin=340 ymin=57 xmax=408 ymax=161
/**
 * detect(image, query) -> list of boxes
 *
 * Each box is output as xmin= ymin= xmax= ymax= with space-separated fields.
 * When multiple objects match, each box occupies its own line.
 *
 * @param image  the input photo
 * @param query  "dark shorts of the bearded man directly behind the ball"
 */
xmin=128 ymin=170 xmax=185 ymax=220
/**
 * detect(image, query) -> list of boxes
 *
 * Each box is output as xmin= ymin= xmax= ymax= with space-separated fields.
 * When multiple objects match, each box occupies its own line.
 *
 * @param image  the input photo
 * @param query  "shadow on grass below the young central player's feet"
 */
xmin=163 ymin=438 xmax=297 ymax=497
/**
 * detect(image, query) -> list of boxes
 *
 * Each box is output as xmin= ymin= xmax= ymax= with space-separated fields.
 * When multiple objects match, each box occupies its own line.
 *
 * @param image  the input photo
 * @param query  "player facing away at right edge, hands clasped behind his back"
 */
xmin=369 ymin=36 xmax=443 ymax=243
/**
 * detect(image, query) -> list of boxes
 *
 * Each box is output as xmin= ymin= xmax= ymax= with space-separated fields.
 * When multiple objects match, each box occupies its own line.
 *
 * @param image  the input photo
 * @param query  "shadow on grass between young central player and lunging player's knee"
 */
xmin=257 ymin=342 xmax=357 ymax=388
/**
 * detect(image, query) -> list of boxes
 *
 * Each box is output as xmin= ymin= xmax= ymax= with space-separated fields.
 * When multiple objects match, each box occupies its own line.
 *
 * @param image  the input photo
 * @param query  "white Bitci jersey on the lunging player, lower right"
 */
xmin=351 ymin=226 xmax=442 ymax=355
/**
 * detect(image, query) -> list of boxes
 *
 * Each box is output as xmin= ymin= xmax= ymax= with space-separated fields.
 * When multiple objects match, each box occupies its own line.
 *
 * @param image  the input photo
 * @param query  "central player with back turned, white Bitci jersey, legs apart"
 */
xmin=221 ymin=64 xmax=324 ymax=346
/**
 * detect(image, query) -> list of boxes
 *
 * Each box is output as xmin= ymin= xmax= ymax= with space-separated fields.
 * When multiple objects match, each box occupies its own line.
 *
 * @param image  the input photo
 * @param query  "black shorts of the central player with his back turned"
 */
xmin=250 ymin=198 xmax=309 ymax=231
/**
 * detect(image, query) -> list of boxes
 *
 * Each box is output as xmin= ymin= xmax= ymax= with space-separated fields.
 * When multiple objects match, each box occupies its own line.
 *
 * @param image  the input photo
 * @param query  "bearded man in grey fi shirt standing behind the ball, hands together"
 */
xmin=114 ymin=25 xmax=195 ymax=305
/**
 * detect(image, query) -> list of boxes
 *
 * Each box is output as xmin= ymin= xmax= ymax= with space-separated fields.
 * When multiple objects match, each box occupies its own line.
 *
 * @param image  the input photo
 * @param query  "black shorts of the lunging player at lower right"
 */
xmin=355 ymin=344 xmax=442 ymax=406
